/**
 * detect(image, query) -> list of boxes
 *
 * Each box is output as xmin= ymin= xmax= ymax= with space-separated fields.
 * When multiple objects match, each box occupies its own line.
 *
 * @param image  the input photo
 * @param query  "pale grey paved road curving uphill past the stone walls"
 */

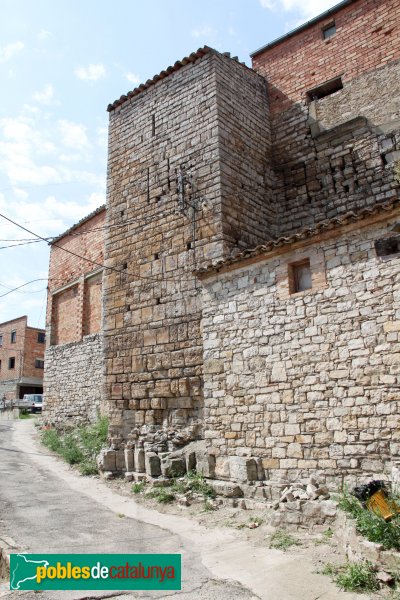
xmin=0 ymin=420 xmax=365 ymax=600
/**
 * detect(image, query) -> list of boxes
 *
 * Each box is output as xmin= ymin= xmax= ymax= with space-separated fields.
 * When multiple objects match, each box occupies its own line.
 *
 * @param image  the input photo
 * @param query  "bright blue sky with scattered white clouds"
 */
xmin=0 ymin=0 xmax=338 ymax=327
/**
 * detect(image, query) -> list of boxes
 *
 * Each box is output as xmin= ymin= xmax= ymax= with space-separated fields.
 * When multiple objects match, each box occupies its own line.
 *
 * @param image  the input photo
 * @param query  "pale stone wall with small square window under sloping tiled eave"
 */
xmin=202 ymin=214 xmax=400 ymax=484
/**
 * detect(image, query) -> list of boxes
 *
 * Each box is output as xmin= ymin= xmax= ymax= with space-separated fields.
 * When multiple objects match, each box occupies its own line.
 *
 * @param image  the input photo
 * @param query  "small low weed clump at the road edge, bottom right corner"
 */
xmin=322 ymin=561 xmax=379 ymax=592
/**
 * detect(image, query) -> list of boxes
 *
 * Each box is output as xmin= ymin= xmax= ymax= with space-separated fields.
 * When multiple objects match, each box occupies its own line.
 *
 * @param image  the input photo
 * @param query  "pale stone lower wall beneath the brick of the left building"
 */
xmin=43 ymin=334 xmax=107 ymax=427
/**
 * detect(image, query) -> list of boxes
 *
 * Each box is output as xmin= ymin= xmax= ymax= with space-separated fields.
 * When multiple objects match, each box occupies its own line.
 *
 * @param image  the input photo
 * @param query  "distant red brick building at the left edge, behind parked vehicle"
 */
xmin=0 ymin=316 xmax=45 ymax=400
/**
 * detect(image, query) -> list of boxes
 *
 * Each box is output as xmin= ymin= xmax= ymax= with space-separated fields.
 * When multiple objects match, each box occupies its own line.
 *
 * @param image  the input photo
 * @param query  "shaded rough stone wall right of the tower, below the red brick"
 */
xmin=264 ymin=65 xmax=400 ymax=235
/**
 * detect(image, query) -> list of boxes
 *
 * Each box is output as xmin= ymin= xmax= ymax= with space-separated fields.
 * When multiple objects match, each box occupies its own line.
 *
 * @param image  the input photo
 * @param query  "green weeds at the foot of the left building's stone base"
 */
xmin=42 ymin=417 xmax=108 ymax=475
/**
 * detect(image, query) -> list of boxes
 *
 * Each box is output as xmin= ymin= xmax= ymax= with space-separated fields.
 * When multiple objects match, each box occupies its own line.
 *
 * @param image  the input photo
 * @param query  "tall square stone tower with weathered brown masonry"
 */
xmin=104 ymin=50 xmax=269 ymax=452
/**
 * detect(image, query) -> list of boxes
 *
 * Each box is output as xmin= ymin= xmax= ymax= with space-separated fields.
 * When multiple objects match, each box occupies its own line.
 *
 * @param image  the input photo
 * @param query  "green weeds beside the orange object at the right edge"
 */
xmin=339 ymin=490 xmax=400 ymax=550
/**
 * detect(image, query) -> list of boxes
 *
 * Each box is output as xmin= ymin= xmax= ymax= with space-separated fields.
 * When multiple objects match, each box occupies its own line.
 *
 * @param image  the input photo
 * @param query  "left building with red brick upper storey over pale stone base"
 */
xmin=44 ymin=206 xmax=106 ymax=421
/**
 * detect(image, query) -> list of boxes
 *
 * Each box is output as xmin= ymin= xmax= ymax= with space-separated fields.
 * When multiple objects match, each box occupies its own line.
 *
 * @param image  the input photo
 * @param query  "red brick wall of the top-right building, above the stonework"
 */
xmin=252 ymin=0 xmax=400 ymax=113
